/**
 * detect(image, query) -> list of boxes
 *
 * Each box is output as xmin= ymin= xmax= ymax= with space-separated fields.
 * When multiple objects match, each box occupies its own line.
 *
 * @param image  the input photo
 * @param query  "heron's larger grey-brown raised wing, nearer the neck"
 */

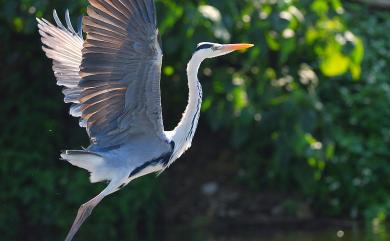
xmin=79 ymin=0 xmax=166 ymax=147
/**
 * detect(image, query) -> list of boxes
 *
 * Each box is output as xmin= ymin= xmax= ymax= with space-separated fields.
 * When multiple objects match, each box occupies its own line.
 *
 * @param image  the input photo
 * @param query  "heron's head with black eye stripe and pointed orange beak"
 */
xmin=194 ymin=42 xmax=254 ymax=59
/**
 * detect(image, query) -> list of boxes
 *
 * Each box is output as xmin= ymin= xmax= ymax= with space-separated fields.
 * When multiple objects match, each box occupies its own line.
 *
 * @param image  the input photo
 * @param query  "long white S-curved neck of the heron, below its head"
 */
xmin=169 ymin=54 xmax=203 ymax=162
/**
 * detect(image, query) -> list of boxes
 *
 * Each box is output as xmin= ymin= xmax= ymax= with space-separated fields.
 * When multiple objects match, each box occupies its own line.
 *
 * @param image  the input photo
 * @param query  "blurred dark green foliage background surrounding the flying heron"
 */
xmin=0 ymin=0 xmax=390 ymax=240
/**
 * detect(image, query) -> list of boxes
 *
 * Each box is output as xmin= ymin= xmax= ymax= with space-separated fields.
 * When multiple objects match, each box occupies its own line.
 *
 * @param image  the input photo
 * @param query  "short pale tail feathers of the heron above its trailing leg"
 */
xmin=61 ymin=150 xmax=108 ymax=183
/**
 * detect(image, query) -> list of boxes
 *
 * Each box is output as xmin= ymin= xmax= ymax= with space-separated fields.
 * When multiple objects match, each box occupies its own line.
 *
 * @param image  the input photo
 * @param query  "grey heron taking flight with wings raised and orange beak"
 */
xmin=37 ymin=0 xmax=253 ymax=241
